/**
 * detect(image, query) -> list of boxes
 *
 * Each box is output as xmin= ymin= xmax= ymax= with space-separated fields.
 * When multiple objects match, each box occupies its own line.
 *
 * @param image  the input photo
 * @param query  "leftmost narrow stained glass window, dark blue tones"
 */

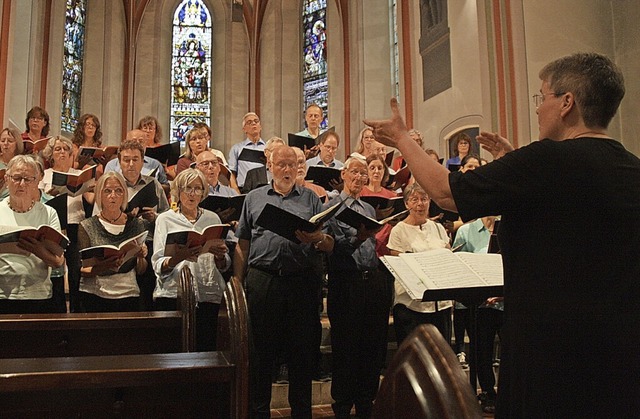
xmin=61 ymin=0 xmax=87 ymax=132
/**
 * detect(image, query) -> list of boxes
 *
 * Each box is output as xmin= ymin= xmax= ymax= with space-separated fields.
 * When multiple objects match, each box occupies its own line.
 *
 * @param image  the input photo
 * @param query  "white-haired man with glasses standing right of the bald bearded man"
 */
xmin=325 ymin=157 xmax=393 ymax=419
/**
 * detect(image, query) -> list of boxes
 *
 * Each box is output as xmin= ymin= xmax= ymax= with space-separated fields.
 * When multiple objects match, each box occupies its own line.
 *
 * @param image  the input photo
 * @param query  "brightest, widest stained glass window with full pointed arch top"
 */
xmin=171 ymin=0 xmax=211 ymax=142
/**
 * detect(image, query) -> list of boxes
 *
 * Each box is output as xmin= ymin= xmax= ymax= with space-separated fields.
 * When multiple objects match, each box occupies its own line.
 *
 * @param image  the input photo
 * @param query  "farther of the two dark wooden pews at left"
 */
xmin=0 ymin=270 xmax=195 ymax=358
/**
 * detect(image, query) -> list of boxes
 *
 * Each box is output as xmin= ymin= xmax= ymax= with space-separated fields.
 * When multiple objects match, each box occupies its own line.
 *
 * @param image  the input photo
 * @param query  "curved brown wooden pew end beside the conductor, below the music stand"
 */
xmin=373 ymin=324 xmax=482 ymax=419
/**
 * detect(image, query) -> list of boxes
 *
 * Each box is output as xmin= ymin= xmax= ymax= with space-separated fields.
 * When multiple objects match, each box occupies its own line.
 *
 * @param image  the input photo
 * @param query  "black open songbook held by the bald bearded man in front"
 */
xmin=256 ymin=201 xmax=342 ymax=243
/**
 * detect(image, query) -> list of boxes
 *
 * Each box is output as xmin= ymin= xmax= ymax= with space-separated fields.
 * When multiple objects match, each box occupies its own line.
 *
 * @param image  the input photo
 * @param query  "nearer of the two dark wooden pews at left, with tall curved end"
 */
xmin=0 ymin=272 xmax=249 ymax=418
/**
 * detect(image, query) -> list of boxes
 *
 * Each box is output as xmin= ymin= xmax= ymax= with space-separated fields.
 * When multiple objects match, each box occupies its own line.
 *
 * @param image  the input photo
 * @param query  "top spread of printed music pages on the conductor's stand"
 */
xmin=400 ymin=249 xmax=504 ymax=289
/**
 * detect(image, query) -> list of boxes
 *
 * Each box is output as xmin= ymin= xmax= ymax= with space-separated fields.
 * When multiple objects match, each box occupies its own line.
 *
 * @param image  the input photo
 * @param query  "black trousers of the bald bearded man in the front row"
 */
xmin=246 ymin=268 xmax=320 ymax=418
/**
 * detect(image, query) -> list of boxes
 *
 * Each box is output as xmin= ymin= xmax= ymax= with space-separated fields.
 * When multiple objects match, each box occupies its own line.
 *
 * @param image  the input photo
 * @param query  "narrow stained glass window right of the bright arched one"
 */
xmin=302 ymin=0 xmax=329 ymax=129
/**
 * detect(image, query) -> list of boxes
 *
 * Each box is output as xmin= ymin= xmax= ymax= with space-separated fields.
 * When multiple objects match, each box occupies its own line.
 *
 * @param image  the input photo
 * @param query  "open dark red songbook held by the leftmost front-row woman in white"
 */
xmin=0 ymin=224 xmax=69 ymax=256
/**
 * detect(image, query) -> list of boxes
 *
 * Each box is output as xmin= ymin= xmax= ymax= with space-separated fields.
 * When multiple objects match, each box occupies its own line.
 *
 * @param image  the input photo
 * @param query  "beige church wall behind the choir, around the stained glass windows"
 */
xmin=2 ymin=0 xmax=640 ymax=158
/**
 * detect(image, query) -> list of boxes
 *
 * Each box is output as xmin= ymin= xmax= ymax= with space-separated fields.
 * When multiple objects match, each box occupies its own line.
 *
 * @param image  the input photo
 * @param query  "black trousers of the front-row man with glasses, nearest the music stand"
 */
xmin=327 ymin=270 xmax=393 ymax=418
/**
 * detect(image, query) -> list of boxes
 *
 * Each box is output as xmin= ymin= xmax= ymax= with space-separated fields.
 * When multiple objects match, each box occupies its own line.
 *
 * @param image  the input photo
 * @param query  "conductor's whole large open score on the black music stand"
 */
xmin=380 ymin=249 xmax=504 ymax=301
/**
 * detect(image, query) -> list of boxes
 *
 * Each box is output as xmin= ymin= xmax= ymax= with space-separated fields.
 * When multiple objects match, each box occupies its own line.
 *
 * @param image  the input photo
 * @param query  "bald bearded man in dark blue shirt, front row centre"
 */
xmin=234 ymin=145 xmax=333 ymax=418
